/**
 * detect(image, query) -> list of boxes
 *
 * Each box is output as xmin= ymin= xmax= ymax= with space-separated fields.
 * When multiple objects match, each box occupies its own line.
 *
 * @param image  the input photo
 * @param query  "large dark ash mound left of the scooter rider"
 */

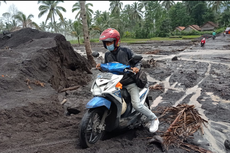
xmin=0 ymin=28 xmax=92 ymax=108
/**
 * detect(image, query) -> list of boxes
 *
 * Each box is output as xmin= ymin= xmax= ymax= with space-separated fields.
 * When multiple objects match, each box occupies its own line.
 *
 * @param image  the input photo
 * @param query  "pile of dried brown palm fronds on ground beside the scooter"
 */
xmin=159 ymin=104 xmax=211 ymax=153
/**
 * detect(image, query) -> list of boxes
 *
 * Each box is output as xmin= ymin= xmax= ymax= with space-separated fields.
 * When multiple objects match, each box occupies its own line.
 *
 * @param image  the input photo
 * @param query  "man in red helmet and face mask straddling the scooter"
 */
xmin=96 ymin=28 xmax=159 ymax=133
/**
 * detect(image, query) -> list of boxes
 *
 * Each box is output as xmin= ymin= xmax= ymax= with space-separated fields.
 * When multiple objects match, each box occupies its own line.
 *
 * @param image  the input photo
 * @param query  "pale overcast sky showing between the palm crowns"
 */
xmin=0 ymin=1 xmax=138 ymax=25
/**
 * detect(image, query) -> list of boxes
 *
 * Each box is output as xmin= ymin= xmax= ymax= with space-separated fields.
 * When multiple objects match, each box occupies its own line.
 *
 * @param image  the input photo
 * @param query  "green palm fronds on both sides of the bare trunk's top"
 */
xmin=72 ymin=1 xmax=93 ymax=19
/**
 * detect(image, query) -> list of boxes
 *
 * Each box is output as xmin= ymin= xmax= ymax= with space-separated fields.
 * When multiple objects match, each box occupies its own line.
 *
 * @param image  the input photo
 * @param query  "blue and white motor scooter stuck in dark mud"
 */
xmin=79 ymin=52 xmax=149 ymax=148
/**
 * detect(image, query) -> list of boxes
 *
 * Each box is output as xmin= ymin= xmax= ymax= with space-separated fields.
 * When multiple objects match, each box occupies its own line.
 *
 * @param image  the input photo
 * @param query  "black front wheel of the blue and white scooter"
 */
xmin=79 ymin=107 xmax=106 ymax=148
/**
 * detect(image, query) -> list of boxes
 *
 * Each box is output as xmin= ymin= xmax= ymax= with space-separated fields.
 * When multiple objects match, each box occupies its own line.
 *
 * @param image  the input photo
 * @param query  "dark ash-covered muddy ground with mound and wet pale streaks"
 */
xmin=0 ymin=29 xmax=230 ymax=153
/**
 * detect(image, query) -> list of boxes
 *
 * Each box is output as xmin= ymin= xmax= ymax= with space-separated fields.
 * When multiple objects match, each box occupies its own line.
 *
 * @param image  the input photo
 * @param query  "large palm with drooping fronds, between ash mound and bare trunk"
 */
xmin=38 ymin=1 xmax=66 ymax=32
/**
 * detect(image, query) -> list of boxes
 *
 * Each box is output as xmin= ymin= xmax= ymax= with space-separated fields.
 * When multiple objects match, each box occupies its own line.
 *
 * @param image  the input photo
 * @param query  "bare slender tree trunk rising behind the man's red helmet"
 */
xmin=80 ymin=1 xmax=96 ymax=67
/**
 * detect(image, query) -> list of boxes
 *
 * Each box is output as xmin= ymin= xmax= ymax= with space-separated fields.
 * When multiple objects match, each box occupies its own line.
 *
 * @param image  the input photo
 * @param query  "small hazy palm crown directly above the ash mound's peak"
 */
xmin=13 ymin=11 xmax=38 ymax=28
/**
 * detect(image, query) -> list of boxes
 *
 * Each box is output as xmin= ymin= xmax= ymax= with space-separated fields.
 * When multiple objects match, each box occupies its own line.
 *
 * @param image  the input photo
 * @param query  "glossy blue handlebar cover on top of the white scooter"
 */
xmin=101 ymin=63 xmax=130 ymax=74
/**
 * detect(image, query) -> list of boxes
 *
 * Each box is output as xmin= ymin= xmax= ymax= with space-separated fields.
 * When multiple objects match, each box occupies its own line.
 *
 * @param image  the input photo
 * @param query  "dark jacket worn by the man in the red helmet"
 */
xmin=105 ymin=47 xmax=141 ymax=69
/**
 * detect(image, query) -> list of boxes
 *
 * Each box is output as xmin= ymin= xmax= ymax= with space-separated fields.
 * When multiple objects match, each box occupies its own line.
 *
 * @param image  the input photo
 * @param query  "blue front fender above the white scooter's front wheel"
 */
xmin=86 ymin=97 xmax=111 ymax=109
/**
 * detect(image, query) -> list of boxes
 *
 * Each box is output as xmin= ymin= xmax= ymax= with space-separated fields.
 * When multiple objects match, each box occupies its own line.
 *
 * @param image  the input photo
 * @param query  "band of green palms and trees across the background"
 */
xmin=0 ymin=1 xmax=230 ymax=39
